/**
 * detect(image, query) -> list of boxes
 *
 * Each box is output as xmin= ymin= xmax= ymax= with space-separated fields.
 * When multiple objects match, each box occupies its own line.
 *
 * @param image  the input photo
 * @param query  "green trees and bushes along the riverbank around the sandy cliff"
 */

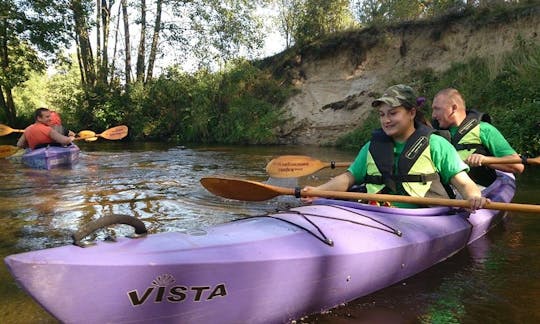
xmin=0 ymin=0 xmax=540 ymax=154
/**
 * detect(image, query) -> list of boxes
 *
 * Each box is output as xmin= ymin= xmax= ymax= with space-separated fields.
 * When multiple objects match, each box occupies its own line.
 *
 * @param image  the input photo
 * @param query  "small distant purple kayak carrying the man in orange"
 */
xmin=22 ymin=144 xmax=80 ymax=170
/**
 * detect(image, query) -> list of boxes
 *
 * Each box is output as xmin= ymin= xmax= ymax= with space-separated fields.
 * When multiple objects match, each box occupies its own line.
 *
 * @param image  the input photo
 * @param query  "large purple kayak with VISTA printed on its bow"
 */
xmin=5 ymin=173 xmax=515 ymax=323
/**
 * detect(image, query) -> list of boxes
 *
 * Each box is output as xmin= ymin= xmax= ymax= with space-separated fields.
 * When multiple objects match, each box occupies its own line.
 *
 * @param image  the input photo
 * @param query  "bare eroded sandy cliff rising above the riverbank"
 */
xmin=277 ymin=9 xmax=540 ymax=145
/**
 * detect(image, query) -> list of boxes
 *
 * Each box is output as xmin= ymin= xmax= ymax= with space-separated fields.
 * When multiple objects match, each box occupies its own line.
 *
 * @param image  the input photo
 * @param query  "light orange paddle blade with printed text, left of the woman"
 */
xmin=266 ymin=155 xmax=330 ymax=178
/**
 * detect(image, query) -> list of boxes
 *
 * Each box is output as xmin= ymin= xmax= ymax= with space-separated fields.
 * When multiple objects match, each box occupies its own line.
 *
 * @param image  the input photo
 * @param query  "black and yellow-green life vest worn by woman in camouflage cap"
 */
xmin=364 ymin=124 xmax=449 ymax=198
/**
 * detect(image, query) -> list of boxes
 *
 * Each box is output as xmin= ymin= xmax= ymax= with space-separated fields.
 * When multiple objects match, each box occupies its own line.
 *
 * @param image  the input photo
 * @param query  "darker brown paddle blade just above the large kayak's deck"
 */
xmin=201 ymin=177 xmax=294 ymax=201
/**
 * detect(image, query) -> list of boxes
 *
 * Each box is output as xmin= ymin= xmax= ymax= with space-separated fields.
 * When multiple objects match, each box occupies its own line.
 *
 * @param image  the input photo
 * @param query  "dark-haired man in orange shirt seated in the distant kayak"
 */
xmin=17 ymin=108 xmax=75 ymax=149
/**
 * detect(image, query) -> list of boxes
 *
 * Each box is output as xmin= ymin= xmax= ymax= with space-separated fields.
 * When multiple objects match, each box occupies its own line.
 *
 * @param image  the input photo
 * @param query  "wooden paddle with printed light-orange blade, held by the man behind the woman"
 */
xmin=266 ymin=155 xmax=540 ymax=178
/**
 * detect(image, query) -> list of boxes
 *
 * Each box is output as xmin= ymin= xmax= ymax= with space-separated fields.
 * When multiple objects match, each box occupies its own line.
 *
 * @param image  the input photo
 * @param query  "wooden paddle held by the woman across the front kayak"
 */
xmin=201 ymin=177 xmax=540 ymax=213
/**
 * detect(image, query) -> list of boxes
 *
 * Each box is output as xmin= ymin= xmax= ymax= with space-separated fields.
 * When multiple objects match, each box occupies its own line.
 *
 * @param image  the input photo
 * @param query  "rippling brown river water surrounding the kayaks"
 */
xmin=0 ymin=141 xmax=540 ymax=323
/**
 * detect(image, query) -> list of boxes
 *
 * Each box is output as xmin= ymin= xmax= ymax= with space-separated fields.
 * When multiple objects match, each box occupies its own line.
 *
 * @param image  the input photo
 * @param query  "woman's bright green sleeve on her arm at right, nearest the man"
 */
xmin=429 ymin=135 xmax=469 ymax=183
